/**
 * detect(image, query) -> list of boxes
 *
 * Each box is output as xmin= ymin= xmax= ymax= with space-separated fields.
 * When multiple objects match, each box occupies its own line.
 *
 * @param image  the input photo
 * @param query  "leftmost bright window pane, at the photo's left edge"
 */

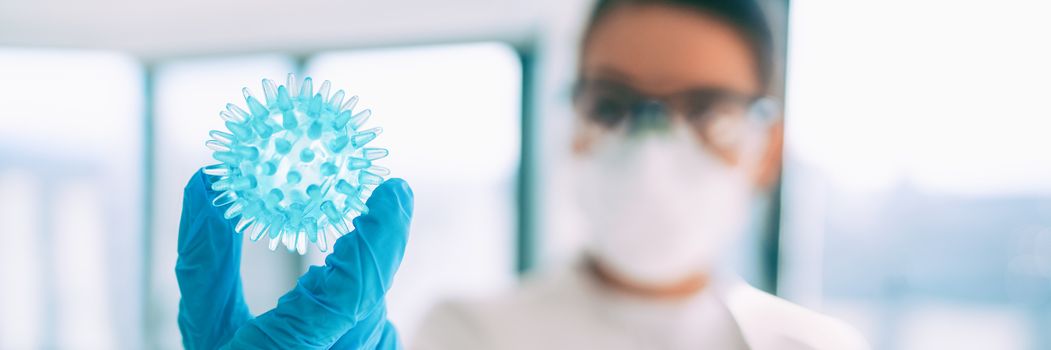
xmin=0 ymin=48 xmax=144 ymax=349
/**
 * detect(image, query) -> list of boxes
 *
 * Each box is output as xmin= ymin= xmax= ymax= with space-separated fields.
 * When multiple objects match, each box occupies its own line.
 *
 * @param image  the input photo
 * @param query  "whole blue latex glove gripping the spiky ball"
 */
xmin=176 ymin=168 xmax=413 ymax=349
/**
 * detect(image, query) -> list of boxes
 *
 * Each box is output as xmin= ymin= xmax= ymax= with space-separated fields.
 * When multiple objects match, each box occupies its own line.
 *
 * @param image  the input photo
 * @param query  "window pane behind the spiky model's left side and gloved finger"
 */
xmin=150 ymin=55 xmax=298 ymax=348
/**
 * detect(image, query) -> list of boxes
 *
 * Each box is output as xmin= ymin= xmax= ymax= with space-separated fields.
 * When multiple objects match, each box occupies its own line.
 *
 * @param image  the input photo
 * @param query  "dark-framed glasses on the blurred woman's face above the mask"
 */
xmin=573 ymin=80 xmax=778 ymax=152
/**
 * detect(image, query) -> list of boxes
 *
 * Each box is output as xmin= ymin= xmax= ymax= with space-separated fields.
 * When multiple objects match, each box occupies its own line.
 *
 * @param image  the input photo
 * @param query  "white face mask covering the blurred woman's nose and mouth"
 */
xmin=577 ymin=127 xmax=755 ymax=286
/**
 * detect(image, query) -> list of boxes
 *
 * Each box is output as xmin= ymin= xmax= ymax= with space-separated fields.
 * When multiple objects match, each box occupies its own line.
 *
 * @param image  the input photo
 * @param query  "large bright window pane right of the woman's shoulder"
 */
xmin=781 ymin=0 xmax=1051 ymax=349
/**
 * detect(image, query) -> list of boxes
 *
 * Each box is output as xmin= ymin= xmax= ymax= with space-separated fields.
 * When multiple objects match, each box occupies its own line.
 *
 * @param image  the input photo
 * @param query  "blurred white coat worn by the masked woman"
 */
xmin=411 ymin=261 xmax=868 ymax=350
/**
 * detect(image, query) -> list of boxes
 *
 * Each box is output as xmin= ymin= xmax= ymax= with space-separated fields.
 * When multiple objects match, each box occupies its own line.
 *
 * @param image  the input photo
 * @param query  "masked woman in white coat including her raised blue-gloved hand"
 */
xmin=176 ymin=0 xmax=866 ymax=349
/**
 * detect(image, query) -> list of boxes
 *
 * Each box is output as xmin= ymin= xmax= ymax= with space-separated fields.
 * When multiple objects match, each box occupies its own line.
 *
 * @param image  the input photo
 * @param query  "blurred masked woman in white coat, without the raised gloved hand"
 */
xmin=414 ymin=0 xmax=866 ymax=349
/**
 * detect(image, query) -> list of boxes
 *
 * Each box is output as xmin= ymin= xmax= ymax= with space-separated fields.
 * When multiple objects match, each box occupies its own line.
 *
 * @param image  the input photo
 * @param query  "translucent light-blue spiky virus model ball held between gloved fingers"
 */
xmin=204 ymin=75 xmax=390 ymax=254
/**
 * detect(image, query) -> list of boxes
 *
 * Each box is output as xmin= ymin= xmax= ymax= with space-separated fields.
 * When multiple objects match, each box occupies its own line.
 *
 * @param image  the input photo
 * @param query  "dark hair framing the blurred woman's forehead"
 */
xmin=581 ymin=0 xmax=774 ymax=90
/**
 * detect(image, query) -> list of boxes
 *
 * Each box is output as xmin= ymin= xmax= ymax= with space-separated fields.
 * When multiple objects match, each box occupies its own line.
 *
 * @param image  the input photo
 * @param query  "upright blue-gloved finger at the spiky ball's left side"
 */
xmin=176 ymin=170 xmax=251 ymax=349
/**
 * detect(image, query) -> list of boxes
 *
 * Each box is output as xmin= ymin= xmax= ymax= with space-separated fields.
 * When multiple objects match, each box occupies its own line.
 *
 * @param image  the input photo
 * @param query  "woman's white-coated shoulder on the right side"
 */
xmin=724 ymin=282 xmax=869 ymax=349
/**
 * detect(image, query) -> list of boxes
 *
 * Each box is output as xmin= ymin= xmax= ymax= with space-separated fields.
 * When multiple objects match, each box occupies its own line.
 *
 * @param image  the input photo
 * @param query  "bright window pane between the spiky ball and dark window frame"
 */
xmin=308 ymin=43 xmax=522 ymax=341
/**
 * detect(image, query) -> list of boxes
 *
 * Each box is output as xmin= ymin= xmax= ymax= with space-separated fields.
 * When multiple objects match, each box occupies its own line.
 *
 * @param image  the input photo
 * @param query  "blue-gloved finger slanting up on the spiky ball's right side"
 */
xmin=225 ymin=179 xmax=413 ymax=349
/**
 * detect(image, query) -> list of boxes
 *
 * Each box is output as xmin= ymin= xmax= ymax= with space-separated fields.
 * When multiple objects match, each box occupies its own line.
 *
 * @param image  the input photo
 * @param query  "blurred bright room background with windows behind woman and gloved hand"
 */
xmin=0 ymin=0 xmax=1051 ymax=349
